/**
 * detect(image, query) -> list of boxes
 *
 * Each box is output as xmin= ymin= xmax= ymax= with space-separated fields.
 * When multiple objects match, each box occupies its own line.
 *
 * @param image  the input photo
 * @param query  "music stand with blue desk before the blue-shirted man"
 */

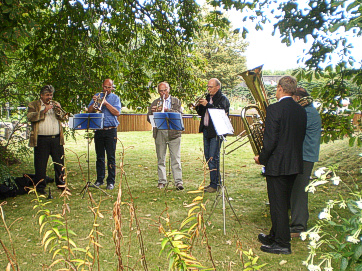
xmin=72 ymin=113 xmax=112 ymax=198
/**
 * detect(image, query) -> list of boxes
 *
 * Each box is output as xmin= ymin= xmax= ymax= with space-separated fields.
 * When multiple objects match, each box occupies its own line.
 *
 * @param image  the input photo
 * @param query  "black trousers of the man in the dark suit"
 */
xmin=266 ymin=174 xmax=297 ymax=247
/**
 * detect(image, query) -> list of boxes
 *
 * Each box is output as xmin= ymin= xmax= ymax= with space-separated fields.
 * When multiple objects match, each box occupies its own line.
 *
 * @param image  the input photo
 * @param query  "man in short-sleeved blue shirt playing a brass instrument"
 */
xmin=88 ymin=79 xmax=122 ymax=190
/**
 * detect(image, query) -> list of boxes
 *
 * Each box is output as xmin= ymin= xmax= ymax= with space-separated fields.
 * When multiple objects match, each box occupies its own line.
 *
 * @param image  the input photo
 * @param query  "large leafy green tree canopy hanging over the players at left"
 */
xmin=0 ymin=0 xmax=204 ymax=112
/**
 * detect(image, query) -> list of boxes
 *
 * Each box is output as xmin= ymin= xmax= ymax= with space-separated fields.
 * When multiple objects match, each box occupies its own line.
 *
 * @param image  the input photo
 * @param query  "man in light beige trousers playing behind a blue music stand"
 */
xmin=147 ymin=82 xmax=184 ymax=190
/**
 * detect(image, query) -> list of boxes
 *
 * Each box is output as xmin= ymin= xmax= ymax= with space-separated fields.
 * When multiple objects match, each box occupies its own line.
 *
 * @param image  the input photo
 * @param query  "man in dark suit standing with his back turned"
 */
xmin=254 ymin=76 xmax=307 ymax=254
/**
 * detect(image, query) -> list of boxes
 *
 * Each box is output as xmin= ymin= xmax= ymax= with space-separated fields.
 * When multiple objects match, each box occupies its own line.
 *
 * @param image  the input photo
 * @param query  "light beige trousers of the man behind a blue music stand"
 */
xmin=155 ymin=130 xmax=183 ymax=185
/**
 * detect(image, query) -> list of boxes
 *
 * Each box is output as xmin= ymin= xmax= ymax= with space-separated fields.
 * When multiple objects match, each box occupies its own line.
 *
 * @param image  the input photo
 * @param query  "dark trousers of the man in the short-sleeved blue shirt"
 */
xmin=94 ymin=128 xmax=117 ymax=184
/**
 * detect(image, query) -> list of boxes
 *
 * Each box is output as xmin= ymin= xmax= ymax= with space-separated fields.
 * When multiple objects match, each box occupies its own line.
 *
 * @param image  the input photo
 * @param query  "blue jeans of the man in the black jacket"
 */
xmin=203 ymin=127 xmax=221 ymax=189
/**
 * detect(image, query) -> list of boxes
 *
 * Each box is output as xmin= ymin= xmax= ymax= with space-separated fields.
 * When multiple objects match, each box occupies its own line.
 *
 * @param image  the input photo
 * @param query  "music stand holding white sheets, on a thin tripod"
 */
xmin=207 ymin=108 xmax=241 ymax=235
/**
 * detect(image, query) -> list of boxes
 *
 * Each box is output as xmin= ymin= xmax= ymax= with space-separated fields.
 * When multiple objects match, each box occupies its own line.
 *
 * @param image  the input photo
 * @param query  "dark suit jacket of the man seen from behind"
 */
xmin=259 ymin=97 xmax=307 ymax=176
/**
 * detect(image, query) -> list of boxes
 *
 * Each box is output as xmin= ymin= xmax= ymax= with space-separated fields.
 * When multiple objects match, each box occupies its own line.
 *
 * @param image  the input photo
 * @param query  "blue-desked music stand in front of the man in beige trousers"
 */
xmin=153 ymin=112 xmax=185 ymax=191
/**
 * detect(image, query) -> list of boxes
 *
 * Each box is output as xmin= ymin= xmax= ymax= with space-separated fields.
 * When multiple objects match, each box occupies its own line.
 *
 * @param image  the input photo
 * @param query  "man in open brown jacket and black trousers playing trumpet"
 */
xmin=27 ymin=85 xmax=68 ymax=194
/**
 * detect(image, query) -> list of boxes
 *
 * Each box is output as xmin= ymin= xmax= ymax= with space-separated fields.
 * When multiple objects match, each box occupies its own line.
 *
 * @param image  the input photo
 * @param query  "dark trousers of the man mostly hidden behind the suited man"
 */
xmin=290 ymin=161 xmax=314 ymax=232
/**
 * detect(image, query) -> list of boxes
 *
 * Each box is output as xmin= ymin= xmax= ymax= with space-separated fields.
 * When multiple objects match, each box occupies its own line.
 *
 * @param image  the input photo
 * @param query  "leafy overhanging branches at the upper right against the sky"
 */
xmin=206 ymin=0 xmax=362 ymax=145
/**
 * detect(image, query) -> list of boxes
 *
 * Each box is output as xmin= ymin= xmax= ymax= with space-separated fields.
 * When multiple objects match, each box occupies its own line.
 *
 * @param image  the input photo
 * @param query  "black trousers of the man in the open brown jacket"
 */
xmin=34 ymin=135 xmax=64 ymax=190
